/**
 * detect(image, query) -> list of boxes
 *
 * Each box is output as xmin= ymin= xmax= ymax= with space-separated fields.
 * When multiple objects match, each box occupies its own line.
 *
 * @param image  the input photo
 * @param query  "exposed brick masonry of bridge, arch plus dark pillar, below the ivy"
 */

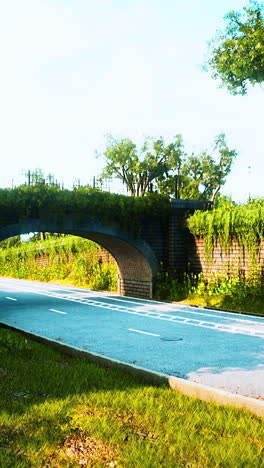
xmin=0 ymin=200 xmax=208 ymax=299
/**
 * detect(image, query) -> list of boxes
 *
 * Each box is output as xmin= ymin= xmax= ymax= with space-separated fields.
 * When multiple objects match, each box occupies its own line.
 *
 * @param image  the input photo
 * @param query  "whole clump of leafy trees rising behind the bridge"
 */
xmin=98 ymin=134 xmax=236 ymax=200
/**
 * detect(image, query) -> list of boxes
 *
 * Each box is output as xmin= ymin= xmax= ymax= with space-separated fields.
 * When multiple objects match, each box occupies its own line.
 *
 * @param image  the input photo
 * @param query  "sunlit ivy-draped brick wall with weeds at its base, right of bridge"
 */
xmin=155 ymin=199 xmax=264 ymax=315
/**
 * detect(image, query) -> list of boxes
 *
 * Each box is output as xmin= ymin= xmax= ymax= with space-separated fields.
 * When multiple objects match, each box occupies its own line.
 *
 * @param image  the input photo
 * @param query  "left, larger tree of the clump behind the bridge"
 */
xmin=98 ymin=135 xmax=182 ymax=197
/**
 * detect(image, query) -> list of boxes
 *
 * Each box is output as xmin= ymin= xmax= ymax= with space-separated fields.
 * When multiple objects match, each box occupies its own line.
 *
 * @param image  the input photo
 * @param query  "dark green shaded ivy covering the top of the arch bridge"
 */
xmin=0 ymin=185 xmax=170 ymax=234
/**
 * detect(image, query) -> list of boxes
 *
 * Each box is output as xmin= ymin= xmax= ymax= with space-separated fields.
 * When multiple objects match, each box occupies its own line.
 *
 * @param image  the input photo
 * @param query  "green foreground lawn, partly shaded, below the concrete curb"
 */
xmin=0 ymin=328 xmax=264 ymax=468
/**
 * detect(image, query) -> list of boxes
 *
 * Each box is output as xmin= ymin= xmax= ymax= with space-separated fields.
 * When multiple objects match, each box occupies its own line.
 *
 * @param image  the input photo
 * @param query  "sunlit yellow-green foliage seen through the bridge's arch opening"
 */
xmin=0 ymin=236 xmax=117 ymax=291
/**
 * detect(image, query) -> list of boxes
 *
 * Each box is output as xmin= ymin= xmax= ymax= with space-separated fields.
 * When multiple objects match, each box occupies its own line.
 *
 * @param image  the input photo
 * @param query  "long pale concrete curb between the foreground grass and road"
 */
xmin=0 ymin=322 xmax=264 ymax=417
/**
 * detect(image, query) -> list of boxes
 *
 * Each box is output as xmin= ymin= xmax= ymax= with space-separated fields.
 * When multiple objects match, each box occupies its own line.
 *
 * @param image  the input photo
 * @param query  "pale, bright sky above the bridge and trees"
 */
xmin=0 ymin=0 xmax=264 ymax=203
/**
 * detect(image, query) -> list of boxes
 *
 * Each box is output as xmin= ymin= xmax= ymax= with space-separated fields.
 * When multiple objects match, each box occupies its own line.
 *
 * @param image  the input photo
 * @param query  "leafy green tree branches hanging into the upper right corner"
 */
xmin=205 ymin=1 xmax=264 ymax=95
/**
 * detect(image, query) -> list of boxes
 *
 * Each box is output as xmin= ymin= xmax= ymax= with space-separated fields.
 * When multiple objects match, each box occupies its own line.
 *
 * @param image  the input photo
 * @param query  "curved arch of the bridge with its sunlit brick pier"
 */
xmin=0 ymin=219 xmax=159 ymax=299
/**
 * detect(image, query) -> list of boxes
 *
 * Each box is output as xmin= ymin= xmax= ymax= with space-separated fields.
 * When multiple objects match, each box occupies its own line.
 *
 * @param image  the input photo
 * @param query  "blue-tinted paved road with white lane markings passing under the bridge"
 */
xmin=0 ymin=278 xmax=264 ymax=398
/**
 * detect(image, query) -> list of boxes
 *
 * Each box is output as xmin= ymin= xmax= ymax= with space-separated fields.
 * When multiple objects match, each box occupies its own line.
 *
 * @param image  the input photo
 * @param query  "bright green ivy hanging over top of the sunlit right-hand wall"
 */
xmin=188 ymin=199 xmax=264 ymax=257
